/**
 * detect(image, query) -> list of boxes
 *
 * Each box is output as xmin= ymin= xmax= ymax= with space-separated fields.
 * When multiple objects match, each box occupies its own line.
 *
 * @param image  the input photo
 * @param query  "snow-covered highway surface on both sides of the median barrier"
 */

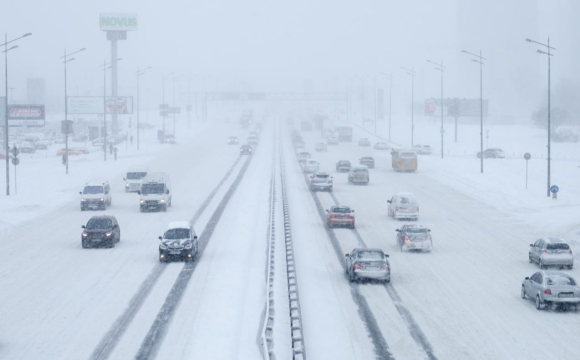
xmin=0 ymin=119 xmax=580 ymax=360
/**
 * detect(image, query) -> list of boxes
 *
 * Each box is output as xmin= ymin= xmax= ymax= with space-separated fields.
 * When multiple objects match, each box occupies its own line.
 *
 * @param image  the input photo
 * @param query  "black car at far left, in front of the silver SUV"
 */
xmin=81 ymin=215 xmax=121 ymax=249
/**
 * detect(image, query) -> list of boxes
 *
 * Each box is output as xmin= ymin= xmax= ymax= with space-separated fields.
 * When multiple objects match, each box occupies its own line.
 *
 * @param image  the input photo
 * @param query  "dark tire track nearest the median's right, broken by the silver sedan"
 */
xmin=288 ymin=143 xmax=395 ymax=360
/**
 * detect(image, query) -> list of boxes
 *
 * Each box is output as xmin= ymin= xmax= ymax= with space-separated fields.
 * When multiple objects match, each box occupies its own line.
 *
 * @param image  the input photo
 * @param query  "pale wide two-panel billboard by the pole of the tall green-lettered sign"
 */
xmin=67 ymin=96 xmax=133 ymax=115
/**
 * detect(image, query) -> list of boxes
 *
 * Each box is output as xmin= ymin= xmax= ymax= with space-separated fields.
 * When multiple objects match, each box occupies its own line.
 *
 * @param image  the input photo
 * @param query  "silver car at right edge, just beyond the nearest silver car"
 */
xmin=528 ymin=238 xmax=574 ymax=269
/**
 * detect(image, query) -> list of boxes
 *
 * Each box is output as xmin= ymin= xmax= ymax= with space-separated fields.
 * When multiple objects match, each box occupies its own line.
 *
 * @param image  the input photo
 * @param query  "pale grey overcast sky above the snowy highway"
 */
xmin=0 ymin=0 xmax=580 ymax=116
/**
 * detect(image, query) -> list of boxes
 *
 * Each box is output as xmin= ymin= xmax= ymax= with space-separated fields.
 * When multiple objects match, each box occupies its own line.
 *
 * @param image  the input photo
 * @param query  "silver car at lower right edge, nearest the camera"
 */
xmin=521 ymin=270 xmax=580 ymax=310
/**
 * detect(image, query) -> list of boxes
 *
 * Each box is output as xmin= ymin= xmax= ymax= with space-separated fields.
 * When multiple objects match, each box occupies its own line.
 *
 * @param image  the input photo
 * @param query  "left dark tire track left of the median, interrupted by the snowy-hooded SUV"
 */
xmin=90 ymin=156 xmax=241 ymax=360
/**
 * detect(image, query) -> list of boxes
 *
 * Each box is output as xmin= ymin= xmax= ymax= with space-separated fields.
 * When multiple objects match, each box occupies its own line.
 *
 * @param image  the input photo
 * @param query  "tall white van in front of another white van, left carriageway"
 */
xmin=137 ymin=173 xmax=172 ymax=212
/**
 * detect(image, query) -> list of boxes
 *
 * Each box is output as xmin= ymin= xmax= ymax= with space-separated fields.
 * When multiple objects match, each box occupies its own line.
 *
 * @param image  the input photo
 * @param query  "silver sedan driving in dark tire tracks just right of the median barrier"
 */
xmin=344 ymin=248 xmax=391 ymax=283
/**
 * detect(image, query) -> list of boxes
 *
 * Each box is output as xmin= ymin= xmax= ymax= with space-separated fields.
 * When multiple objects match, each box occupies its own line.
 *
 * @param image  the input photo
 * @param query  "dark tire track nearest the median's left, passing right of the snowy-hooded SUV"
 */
xmin=135 ymin=156 xmax=253 ymax=360
